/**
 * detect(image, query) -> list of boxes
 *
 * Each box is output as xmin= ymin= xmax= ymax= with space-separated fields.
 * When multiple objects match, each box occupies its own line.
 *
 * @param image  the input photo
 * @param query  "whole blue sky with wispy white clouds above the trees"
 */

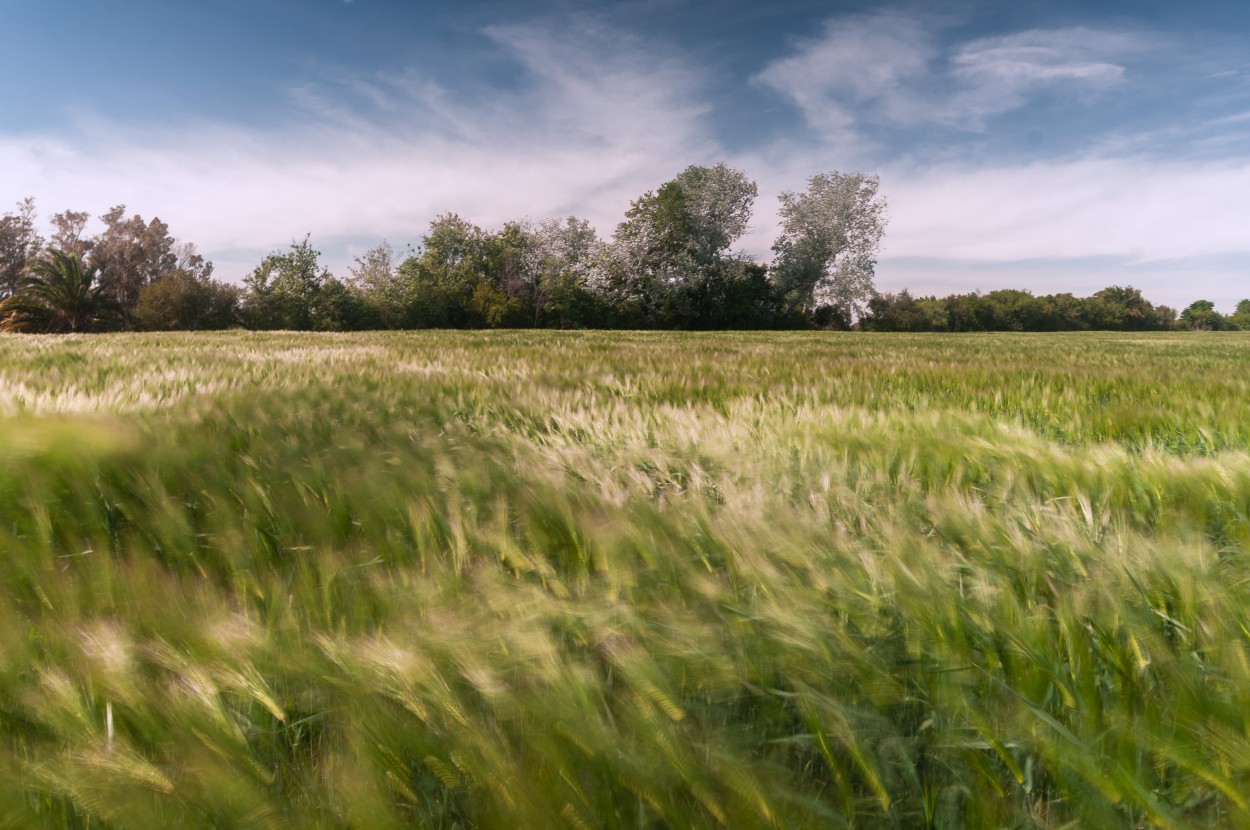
xmin=0 ymin=0 xmax=1250 ymax=310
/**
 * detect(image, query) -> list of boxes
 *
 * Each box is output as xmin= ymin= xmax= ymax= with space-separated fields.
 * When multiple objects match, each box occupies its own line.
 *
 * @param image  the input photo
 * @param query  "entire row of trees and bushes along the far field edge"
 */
xmin=0 ymin=164 xmax=1250 ymax=331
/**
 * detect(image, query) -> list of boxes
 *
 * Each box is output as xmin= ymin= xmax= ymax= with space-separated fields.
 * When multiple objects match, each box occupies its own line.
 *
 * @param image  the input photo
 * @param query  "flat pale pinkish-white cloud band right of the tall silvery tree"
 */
xmin=883 ymin=159 xmax=1250 ymax=260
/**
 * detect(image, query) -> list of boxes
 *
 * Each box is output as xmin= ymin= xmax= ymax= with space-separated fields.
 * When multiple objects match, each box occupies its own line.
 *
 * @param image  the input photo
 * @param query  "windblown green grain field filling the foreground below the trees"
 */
xmin=0 ymin=333 xmax=1250 ymax=830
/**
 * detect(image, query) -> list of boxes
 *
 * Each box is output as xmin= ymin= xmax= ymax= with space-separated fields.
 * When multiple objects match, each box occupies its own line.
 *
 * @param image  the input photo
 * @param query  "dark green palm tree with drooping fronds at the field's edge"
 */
xmin=0 ymin=248 xmax=123 ymax=333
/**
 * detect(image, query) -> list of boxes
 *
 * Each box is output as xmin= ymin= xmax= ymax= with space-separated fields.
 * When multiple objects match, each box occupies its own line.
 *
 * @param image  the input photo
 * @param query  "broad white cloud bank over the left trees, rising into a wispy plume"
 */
xmin=0 ymin=17 xmax=715 ymax=278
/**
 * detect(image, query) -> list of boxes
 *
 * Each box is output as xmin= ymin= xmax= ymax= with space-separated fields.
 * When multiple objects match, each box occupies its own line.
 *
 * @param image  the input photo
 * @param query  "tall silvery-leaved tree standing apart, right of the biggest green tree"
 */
xmin=773 ymin=173 xmax=886 ymax=313
